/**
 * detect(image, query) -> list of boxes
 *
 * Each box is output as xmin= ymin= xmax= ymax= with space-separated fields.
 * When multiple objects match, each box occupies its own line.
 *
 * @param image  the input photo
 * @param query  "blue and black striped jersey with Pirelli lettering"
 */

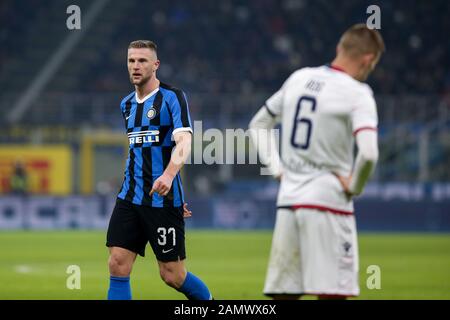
xmin=118 ymin=83 xmax=192 ymax=207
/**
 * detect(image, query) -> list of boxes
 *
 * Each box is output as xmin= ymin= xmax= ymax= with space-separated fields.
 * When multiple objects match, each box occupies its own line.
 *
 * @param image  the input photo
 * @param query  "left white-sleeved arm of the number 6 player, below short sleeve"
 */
xmin=249 ymin=105 xmax=283 ymax=179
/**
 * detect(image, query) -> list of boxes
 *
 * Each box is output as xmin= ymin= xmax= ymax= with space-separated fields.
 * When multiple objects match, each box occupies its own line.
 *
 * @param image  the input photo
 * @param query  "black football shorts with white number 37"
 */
xmin=106 ymin=199 xmax=186 ymax=262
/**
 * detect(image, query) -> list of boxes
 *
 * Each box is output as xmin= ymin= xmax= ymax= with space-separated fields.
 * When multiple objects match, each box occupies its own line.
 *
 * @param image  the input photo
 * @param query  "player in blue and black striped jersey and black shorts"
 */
xmin=106 ymin=40 xmax=212 ymax=300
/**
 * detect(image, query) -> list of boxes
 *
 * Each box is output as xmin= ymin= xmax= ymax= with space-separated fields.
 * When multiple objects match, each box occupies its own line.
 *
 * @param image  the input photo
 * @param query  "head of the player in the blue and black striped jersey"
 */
xmin=127 ymin=40 xmax=160 ymax=87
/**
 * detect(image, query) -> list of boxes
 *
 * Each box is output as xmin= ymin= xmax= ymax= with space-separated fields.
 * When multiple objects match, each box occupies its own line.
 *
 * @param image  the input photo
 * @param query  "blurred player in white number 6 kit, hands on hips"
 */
xmin=250 ymin=24 xmax=384 ymax=299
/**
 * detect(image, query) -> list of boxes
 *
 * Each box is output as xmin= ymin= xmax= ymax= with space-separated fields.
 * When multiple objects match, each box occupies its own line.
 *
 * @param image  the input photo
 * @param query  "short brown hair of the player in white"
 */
xmin=338 ymin=23 xmax=386 ymax=56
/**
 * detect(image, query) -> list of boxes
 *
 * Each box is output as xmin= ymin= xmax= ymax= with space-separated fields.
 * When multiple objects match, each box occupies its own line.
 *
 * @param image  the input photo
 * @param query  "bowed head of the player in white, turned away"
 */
xmin=335 ymin=23 xmax=385 ymax=81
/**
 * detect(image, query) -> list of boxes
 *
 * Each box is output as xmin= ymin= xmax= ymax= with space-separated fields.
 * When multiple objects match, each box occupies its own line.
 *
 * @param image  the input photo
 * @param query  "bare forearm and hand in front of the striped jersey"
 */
xmin=150 ymin=131 xmax=192 ymax=196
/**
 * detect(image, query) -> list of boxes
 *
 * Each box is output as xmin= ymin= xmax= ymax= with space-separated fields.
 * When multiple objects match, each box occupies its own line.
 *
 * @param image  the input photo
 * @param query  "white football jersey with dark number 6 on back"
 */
xmin=265 ymin=66 xmax=378 ymax=213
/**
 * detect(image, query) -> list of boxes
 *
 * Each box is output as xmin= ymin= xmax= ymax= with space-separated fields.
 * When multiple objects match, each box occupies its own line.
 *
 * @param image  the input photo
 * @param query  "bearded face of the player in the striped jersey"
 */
xmin=128 ymin=48 xmax=159 ymax=86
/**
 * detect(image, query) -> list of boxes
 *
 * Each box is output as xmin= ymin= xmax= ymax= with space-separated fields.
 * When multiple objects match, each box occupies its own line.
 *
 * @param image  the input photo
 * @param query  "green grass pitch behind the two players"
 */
xmin=0 ymin=230 xmax=450 ymax=300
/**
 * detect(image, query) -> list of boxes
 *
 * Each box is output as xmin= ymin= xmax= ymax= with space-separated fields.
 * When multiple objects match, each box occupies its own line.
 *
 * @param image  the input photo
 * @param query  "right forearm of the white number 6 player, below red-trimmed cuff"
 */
xmin=348 ymin=130 xmax=378 ymax=195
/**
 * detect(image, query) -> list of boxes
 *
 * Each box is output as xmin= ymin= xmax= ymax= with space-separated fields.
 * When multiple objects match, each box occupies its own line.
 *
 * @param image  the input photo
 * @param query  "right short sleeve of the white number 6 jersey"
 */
xmin=351 ymin=92 xmax=378 ymax=135
